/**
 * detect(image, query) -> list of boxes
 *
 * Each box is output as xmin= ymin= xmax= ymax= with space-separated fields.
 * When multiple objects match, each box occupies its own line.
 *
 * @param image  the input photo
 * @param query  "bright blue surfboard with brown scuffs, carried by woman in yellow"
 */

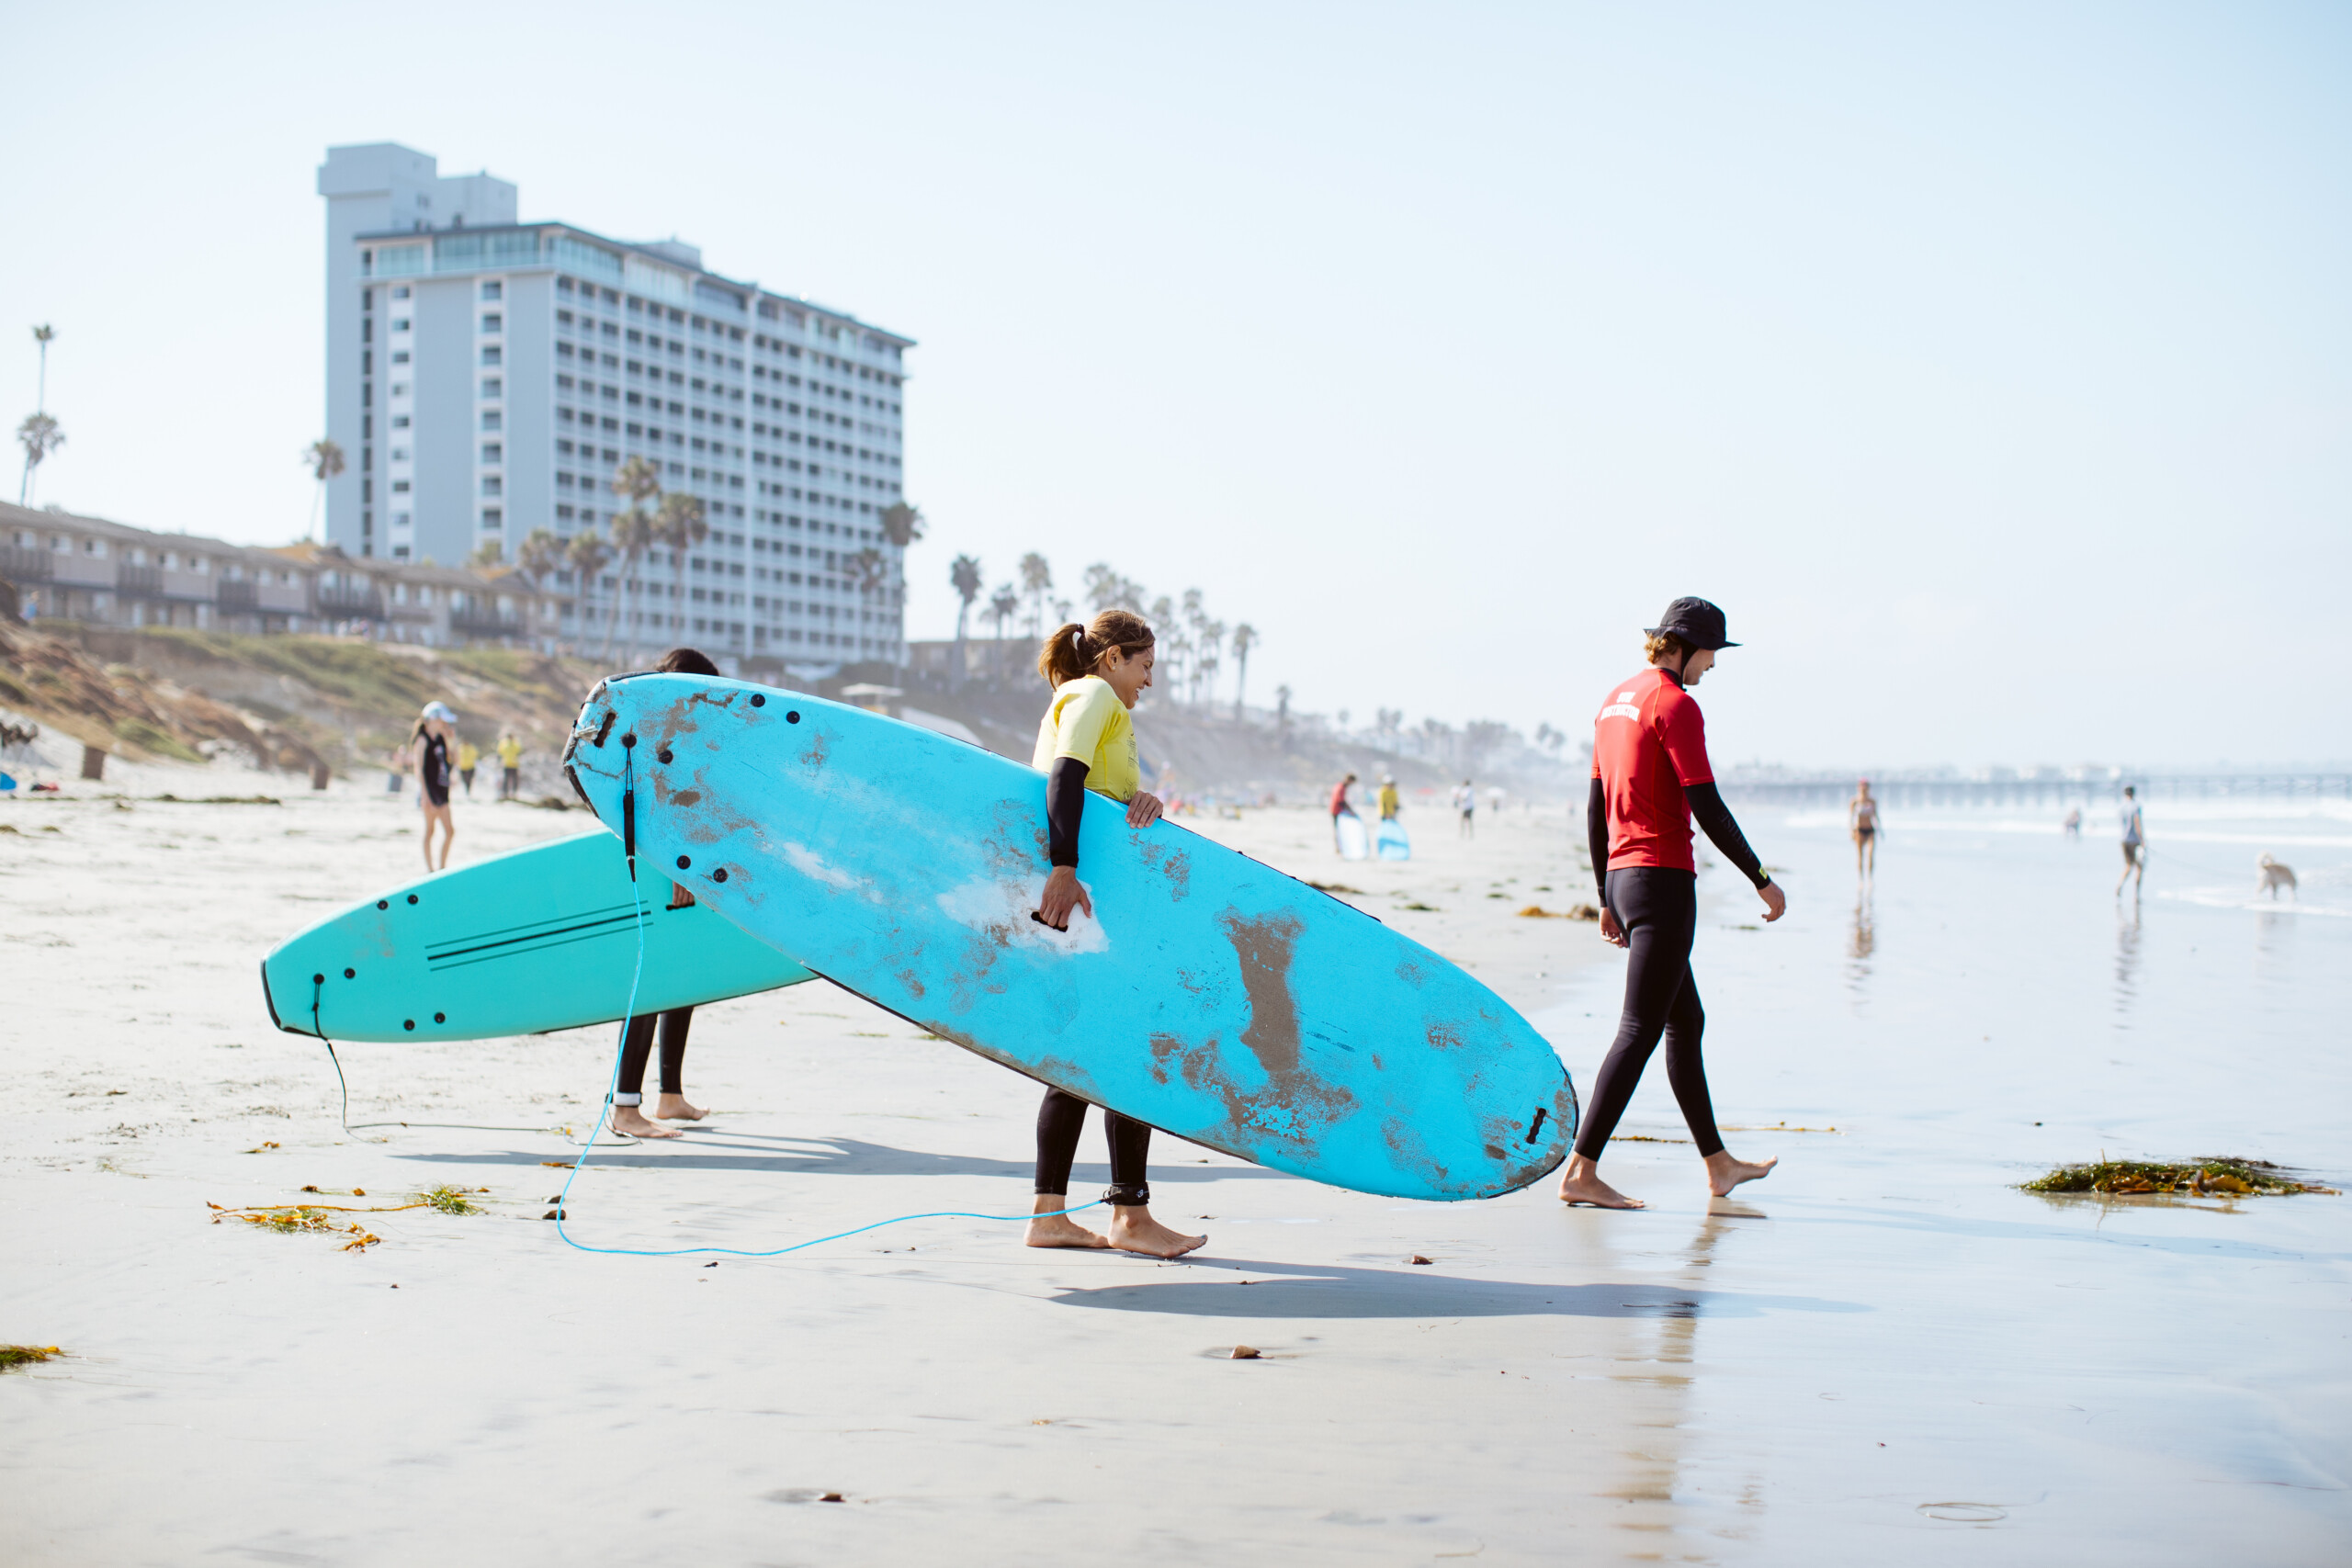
xmin=564 ymin=674 xmax=1576 ymax=1199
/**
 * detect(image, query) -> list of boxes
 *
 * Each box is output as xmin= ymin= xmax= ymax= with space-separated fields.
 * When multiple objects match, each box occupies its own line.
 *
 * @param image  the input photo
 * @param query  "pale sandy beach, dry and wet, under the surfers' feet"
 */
xmin=0 ymin=769 xmax=2352 ymax=1563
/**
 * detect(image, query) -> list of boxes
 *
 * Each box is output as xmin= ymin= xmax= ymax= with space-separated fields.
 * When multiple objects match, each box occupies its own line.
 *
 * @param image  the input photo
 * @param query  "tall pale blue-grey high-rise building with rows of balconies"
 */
xmin=318 ymin=141 xmax=915 ymax=665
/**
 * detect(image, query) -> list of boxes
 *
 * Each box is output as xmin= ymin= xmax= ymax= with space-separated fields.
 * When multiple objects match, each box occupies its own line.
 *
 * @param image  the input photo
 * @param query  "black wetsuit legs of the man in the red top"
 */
xmin=1576 ymin=865 xmax=1724 ymax=1159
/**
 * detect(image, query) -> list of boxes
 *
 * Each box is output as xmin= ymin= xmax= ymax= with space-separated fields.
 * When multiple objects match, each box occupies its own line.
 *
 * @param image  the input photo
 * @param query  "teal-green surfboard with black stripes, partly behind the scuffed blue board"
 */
xmin=261 ymin=832 xmax=814 ymax=1039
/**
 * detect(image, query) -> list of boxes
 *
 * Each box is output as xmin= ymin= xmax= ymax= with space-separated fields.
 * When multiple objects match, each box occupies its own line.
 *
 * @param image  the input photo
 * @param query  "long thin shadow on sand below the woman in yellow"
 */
xmin=1046 ymin=1258 xmax=1870 ymax=1319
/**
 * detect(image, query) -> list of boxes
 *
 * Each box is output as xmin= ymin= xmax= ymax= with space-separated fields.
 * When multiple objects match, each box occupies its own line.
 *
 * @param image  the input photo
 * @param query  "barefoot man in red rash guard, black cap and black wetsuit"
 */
xmin=1559 ymin=600 xmax=1788 ymax=1208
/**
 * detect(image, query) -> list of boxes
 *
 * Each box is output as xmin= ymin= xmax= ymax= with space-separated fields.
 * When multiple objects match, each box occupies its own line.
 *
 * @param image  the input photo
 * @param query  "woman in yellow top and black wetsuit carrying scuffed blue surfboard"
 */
xmin=1025 ymin=609 xmax=1213 ymax=1258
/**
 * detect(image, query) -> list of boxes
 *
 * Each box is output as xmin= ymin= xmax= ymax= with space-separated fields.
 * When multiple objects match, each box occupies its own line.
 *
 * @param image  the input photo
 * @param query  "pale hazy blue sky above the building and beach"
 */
xmin=0 ymin=0 xmax=2352 ymax=764
